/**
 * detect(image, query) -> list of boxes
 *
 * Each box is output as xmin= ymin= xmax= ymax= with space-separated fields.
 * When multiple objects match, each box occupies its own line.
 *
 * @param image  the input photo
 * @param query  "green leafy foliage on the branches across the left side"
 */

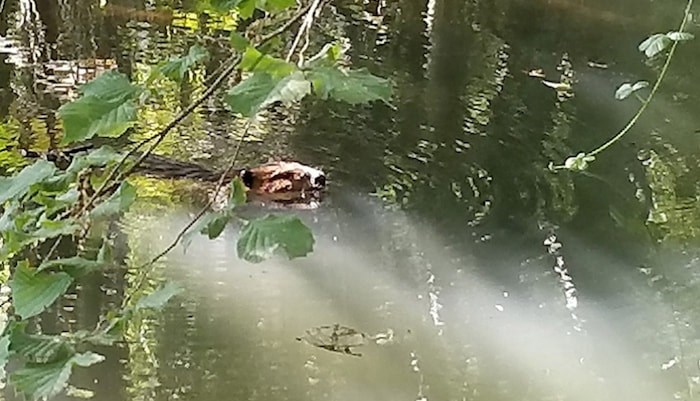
xmin=0 ymin=0 xmax=392 ymax=400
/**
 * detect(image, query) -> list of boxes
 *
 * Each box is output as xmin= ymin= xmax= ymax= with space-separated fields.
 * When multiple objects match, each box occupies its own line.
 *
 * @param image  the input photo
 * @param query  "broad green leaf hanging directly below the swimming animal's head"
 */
xmin=237 ymin=215 xmax=314 ymax=263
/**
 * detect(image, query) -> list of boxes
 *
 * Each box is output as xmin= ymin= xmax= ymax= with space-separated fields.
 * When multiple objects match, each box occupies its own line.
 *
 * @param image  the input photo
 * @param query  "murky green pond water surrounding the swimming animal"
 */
xmin=0 ymin=0 xmax=700 ymax=401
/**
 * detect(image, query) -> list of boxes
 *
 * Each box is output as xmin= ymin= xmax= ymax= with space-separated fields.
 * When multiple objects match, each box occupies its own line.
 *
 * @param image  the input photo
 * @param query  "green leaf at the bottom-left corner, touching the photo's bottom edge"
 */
xmin=10 ymin=352 xmax=104 ymax=401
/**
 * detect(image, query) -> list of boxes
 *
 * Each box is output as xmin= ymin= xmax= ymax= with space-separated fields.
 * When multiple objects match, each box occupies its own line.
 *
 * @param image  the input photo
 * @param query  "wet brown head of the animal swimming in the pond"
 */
xmin=239 ymin=161 xmax=326 ymax=202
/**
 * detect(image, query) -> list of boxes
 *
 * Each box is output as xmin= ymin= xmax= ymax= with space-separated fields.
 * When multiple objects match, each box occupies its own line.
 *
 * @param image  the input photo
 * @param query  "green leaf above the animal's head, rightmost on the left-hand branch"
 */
xmin=307 ymin=67 xmax=392 ymax=104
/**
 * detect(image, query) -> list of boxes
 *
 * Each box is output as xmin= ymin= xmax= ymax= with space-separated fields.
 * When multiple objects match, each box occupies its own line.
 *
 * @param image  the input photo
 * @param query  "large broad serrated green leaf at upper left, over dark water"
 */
xmin=58 ymin=71 xmax=141 ymax=144
